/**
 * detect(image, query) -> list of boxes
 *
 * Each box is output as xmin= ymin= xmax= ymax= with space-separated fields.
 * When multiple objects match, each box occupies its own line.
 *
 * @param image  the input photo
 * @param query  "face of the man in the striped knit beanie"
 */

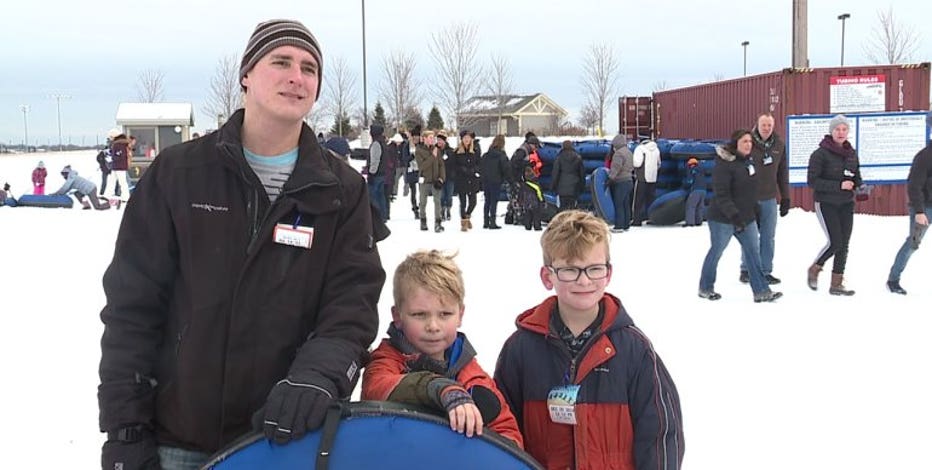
xmin=242 ymin=46 xmax=320 ymax=123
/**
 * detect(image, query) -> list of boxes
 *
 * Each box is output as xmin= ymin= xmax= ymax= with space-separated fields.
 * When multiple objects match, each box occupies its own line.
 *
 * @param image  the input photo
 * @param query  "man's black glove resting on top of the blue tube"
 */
xmin=252 ymin=374 xmax=336 ymax=444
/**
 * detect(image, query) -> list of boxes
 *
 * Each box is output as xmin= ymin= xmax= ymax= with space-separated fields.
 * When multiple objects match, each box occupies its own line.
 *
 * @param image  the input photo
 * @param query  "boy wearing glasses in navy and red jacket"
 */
xmin=495 ymin=210 xmax=683 ymax=470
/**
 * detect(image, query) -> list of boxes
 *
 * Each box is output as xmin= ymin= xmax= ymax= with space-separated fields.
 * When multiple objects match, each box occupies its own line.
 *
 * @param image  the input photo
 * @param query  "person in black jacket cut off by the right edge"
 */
xmin=887 ymin=111 xmax=932 ymax=295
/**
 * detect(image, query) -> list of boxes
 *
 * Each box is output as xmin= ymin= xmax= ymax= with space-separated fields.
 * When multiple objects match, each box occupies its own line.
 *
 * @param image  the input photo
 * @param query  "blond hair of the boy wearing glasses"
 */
xmin=540 ymin=210 xmax=612 ymax=266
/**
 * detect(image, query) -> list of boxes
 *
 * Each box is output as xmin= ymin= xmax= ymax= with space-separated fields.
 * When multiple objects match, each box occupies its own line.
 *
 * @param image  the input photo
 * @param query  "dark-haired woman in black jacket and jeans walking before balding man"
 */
xmin=699 ymin=129 xmax=783 ymax=302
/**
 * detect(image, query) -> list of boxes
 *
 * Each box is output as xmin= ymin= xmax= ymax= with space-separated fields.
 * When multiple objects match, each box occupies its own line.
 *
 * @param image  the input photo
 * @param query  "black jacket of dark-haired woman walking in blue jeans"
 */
xmin=707 ymin=147 xmax=757 ymax=224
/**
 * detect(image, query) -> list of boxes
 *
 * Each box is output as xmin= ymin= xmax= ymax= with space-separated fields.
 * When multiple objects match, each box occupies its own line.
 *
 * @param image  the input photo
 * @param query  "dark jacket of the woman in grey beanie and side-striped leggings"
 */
xmin=808 ymin=135 xmax=861 ymax=204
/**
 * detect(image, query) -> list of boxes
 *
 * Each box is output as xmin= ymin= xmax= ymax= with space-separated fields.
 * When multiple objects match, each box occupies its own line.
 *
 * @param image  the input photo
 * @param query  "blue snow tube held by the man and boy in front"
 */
xmin=204 ymin=402 xmax=541 ymax=470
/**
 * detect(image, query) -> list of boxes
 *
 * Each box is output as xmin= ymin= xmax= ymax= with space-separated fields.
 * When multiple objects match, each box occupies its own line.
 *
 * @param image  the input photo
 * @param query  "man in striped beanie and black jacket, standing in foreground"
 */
xmin=98 ymin=20 xmax=386 ymax=470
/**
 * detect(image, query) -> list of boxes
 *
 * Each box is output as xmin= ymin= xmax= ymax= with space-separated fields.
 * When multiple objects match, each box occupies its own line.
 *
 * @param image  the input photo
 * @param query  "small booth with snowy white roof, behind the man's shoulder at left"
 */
xmin=116 ymin=103 xmax=194 ymax=158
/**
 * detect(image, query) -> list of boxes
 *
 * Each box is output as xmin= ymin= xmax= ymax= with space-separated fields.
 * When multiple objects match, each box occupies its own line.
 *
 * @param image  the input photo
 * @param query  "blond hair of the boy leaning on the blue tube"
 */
xmin=392 ymin=250 xmax=466 ymax=307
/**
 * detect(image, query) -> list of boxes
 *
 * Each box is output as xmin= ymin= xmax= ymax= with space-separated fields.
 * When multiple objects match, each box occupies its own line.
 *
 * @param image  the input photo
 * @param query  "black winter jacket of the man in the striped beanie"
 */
xmin=98 ymin=110 xmax=385 ymax=453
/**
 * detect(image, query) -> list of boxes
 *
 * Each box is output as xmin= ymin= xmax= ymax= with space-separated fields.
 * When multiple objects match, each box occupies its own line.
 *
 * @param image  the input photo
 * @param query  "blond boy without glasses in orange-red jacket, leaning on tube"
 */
xmin=362 ymin=250 xmax=524 ymax=448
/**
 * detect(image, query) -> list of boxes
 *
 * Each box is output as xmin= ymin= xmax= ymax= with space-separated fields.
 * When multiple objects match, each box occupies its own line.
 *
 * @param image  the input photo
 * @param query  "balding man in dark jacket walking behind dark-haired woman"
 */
xmin=738 ymin=113 xmax=790 ymax=285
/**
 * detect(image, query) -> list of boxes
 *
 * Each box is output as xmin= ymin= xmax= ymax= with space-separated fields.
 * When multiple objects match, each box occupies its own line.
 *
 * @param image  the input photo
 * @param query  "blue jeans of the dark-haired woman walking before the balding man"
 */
xmin=699 ymin=220 xmax=770 ymax=294
